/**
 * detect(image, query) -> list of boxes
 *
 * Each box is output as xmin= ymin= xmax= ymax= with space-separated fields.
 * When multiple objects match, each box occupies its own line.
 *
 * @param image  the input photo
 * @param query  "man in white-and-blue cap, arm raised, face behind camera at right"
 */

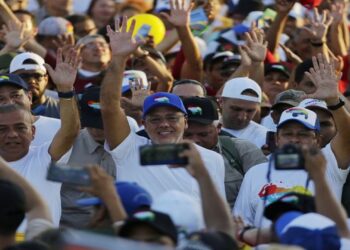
xmin=233 ymin=55 xmax=350 ymax=226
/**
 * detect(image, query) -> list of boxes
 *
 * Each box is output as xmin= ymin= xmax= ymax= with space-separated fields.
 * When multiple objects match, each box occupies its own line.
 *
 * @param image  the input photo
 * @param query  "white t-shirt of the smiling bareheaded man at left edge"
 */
xmin=9 ymin=143 xmax=71 ymax=232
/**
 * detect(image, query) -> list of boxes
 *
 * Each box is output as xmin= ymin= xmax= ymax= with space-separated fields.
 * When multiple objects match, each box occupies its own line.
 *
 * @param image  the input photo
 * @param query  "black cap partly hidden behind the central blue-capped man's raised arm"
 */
xmin=79 ymin=86 xmax=103 ymax=129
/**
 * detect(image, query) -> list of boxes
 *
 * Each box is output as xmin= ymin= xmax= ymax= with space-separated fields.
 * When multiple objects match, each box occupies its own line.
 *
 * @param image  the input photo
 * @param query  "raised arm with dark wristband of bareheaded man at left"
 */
xmin=45 ymin=49 xmax=80 ymax=161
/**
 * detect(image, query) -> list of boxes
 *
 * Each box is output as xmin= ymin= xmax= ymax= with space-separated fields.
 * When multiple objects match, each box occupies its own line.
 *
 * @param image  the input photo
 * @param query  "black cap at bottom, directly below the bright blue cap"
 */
xmin=119 ymin=210 xmax=177 ymax=244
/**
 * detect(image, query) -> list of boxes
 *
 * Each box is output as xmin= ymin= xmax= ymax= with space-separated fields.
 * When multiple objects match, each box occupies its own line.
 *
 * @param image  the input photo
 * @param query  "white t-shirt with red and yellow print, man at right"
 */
xmin=232 ymin=144 xmax=349 ymax=227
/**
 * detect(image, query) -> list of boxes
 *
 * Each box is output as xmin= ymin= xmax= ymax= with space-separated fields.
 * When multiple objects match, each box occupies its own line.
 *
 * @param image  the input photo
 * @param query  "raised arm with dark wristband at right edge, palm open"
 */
xmin=305 ymin=54 xmax=350 ymax=169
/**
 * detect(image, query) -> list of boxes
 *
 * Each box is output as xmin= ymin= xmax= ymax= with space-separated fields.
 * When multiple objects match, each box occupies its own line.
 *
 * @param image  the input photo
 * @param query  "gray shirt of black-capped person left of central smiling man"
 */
xmin=60 ymin=129 xmax=116 ymax=228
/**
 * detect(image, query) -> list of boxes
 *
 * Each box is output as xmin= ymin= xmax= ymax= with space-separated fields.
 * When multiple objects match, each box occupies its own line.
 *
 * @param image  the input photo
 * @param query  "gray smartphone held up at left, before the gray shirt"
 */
xmin=46 ymin=162 xmax=91 ymax=186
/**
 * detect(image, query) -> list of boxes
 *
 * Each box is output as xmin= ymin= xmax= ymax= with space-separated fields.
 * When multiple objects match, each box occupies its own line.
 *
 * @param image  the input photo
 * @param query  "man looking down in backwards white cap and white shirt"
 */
xmin=221 ymin=77 xmax=268 ymax=148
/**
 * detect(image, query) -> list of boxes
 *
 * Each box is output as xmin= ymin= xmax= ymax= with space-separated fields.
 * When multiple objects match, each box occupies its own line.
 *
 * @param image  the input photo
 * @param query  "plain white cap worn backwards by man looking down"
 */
xmin=221 ymin=77 xmax=262 ymax=103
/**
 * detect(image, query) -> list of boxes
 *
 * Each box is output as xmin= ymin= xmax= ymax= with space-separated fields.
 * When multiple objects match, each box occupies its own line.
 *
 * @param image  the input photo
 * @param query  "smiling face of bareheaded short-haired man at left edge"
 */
xmin=0 ymin=110 xmax=35 ymax=162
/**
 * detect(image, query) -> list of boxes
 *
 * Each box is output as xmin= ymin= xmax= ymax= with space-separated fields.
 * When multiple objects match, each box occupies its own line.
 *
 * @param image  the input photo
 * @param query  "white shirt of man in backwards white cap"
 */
xmin=223 ymin=121 xmax=268 ymax=148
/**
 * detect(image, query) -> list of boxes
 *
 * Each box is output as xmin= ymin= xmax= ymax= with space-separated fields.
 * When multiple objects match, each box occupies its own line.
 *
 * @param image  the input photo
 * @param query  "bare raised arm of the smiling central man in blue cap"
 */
xmin=100 ymin=17 xmax=140 ymax=150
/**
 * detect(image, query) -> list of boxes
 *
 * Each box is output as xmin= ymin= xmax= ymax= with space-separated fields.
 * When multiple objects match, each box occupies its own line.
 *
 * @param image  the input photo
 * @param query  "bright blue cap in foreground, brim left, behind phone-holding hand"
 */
xmin=76 ymin=181 xmax=153 ymax=216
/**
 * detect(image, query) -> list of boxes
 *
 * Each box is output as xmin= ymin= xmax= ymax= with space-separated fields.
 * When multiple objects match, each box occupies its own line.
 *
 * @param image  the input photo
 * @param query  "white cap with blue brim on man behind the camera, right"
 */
xmin=277 ymin=107 xmax=320 ymax=131
